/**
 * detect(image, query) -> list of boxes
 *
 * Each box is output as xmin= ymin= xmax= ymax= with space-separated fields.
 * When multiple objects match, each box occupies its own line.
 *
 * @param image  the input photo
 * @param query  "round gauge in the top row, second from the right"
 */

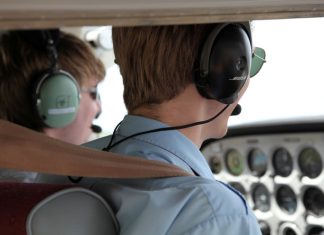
xmin=272 ymin=148 xmax=293 ymax=177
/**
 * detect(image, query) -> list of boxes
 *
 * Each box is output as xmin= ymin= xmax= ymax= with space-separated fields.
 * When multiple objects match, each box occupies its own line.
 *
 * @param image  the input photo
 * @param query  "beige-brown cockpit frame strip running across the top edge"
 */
xmin=0 ymin=0 xmax=324 ymax=29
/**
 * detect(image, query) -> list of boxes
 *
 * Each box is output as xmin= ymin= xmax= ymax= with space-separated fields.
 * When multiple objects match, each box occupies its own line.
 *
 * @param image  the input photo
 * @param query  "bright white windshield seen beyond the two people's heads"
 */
xmin=96 ymin=18 xmax=324 ymax=133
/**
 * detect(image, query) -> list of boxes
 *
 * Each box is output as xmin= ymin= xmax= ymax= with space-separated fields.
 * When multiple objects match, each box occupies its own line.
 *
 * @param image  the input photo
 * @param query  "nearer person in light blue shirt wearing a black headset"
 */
xmin=88 ymin=22 xmax=261 ymax=235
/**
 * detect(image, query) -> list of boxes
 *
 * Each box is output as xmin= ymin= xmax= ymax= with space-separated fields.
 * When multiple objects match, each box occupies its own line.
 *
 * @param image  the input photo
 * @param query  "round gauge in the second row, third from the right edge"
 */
xmin=252 ymin=184 xmax=270 ymax=212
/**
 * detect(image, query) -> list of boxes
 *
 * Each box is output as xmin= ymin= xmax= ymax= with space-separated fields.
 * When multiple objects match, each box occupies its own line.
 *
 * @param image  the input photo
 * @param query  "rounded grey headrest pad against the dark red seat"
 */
xmin=26 ymin=187 xmax=119 ymax=235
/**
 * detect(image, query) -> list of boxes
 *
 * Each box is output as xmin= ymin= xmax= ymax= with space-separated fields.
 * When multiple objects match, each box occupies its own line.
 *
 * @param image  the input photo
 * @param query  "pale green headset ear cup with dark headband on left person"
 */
xmin=25 ymin=30 xmax=80 ymax=128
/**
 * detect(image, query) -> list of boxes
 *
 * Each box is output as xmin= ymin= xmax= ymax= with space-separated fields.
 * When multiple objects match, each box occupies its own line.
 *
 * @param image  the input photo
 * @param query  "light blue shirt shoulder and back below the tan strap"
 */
xmin=95 ymin=177 xmax=259 ymax=235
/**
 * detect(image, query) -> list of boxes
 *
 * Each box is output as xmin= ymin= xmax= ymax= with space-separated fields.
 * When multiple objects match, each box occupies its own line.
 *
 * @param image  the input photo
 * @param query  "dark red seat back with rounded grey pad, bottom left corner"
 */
xmin=0 ymin=182 xmax=118 ymax=235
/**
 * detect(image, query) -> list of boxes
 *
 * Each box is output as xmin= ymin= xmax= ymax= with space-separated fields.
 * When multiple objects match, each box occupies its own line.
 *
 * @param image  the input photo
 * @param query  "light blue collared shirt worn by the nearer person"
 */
xmin=83 ymin=115 xmax=261 ymax=235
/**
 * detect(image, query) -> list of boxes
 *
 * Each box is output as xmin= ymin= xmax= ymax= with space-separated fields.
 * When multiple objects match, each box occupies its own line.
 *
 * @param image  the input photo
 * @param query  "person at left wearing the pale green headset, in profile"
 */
xmin=0 ymin=29 xmax=105 ymax=181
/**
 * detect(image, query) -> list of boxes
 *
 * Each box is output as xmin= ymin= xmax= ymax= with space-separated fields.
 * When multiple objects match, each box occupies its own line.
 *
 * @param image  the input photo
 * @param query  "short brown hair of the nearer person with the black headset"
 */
xmin=112 ymin=24 xmax=215 ymax=113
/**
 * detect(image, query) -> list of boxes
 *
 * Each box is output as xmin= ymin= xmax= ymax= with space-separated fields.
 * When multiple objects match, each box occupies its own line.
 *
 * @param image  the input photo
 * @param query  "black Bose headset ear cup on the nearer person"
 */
xmin=194 ymin=22 xmax=265 ymax=104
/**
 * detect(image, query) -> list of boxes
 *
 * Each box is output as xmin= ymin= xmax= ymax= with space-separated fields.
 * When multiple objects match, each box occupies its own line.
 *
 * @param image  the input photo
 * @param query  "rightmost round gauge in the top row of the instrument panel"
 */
xmin=298 ymin=148 xmax=323 ymax=178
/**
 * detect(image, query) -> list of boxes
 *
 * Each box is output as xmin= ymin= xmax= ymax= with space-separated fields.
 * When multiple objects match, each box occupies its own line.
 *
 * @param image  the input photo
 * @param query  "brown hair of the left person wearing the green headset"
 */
xmin=0 ymin=31 xmax=105 ymax=131
